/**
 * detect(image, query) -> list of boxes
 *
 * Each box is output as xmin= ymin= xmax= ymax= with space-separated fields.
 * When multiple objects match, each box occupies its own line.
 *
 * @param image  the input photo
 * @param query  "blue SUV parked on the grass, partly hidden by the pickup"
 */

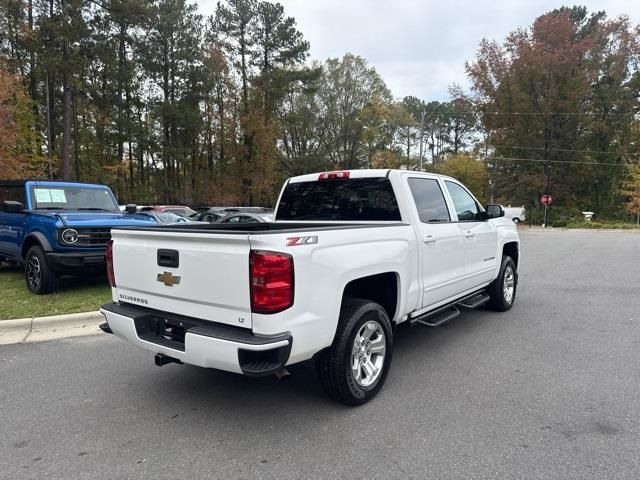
xmin=0 ymin=181 xmax=157 ymax=294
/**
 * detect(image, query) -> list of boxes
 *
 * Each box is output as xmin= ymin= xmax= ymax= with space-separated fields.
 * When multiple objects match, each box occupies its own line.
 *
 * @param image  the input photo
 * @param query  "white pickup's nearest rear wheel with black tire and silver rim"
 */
xmin=316 ymin=299 xmax=393 ymax=405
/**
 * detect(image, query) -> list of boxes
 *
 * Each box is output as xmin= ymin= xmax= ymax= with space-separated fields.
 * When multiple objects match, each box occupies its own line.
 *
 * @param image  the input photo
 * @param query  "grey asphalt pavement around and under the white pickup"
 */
xmin=0 ymin=231 xmax=640 ymax=480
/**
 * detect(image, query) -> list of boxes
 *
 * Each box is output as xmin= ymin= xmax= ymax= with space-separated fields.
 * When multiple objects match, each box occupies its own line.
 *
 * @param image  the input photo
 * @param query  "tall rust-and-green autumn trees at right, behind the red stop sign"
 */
xmin=467 ymin=7 xmax=640 ymax=215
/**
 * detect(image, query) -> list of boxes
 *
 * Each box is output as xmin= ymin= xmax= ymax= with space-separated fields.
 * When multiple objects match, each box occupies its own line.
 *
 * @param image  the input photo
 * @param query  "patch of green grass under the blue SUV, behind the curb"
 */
xmin=0 ymin=265 xmax=111 ymax=320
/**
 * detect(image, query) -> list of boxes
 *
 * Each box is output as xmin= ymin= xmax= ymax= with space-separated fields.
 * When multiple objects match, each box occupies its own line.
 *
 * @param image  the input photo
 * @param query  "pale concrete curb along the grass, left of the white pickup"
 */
xmin=0 ymin=312 xmax=104 ymax=345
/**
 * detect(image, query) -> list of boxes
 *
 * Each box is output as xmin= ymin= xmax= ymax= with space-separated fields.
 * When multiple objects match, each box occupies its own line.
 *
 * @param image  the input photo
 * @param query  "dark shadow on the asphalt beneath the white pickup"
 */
xmin=111 ymin=310 xmax=507 ymax=422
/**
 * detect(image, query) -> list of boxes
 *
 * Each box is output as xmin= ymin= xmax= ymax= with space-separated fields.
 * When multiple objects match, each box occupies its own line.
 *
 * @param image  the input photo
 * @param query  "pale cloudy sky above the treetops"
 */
xmin=196 ymin=0 xmax=640 ymax=101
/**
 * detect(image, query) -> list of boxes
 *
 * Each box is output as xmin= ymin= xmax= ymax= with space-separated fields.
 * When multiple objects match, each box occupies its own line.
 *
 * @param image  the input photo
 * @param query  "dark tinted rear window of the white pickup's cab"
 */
xmin=276 ymin=178 xmax=401 ymax=222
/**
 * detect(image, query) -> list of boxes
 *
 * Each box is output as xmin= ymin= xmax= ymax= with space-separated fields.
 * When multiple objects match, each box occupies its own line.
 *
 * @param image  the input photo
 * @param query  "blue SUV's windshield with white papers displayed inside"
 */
xmin=32 ymin=185 xmax=120 ymax=213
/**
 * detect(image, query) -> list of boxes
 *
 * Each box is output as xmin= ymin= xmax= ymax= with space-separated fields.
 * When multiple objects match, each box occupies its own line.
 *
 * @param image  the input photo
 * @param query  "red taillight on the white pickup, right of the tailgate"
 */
xmin=249 ymin=250 xmax=293 ymax=313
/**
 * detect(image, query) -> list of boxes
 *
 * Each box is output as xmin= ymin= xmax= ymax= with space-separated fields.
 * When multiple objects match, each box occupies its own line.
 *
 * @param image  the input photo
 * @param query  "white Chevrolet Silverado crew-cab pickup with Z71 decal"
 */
xmin=101 ymin=170 xmax=520 ymax=405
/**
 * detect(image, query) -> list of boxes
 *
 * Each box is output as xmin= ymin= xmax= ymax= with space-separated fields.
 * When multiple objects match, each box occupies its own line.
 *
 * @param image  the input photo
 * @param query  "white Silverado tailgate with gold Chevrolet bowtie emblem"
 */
xmin=112 ymin=229 xmax=252 ymax=328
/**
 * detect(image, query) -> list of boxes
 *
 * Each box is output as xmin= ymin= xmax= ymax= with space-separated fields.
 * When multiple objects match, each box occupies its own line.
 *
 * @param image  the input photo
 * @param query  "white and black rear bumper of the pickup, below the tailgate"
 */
xmin=100 ymin=303 xmax=292 ymax=376
